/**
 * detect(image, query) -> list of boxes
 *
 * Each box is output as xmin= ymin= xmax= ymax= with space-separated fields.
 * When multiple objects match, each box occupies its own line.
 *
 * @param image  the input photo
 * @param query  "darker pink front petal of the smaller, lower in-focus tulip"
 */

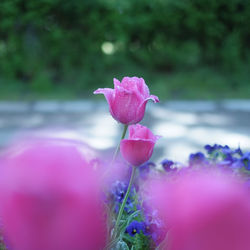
xmin=120 ymin=139 xmax=155 ymax=166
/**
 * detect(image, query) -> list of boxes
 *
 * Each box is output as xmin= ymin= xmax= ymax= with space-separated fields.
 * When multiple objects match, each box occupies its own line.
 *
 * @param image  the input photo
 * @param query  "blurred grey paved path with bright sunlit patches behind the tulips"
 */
xmin=0 ymin=100 xmax=250 ymax=161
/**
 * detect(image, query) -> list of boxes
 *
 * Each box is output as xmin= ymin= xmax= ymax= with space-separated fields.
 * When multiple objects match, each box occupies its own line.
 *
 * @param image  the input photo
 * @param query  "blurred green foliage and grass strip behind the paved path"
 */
xmin=0 ymin=0 xmax=250 ymax=100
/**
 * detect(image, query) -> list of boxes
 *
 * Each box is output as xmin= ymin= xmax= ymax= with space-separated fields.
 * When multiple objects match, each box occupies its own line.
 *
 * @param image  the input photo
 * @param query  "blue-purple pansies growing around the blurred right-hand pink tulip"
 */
xmin=107 ymin=144 xmax=250 ymax=247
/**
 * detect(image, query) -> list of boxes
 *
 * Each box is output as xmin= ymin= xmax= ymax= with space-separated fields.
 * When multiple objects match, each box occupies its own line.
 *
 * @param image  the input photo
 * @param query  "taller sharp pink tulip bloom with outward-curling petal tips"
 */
xmin=94 ymin=77 xmax=159 ymax=125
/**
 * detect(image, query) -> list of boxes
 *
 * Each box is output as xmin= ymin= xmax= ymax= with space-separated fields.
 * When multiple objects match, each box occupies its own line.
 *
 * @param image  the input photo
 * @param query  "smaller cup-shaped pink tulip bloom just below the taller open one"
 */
xmin=120 ymin=124 xmax=160 ymax=166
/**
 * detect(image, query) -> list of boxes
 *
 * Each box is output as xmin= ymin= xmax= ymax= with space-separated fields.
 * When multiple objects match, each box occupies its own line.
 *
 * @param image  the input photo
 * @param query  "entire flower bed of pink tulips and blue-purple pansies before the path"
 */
xmin=0 ymin=77 xmax=250 ymax=250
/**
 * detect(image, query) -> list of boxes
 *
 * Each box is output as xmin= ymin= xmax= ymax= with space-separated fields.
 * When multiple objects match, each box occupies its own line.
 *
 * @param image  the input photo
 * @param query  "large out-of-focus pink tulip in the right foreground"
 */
xmin=146 ymin=171 xmax=250 ymax=250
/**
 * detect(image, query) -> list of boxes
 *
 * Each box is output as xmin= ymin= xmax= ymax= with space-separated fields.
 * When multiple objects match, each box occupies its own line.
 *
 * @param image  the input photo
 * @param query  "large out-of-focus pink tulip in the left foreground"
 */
xmin=0 ymin=141 xmax=107 ymax=250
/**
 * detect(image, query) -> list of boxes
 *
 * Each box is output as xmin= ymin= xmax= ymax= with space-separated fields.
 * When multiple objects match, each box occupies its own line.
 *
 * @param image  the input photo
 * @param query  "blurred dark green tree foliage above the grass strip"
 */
xmin=0 ymin=0 xmax=250 ymax=95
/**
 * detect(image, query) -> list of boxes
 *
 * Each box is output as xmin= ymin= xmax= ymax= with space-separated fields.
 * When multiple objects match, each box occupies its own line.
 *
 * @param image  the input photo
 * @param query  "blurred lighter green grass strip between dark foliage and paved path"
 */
xmin=0 ymin=65 xmax=250 ymax=100
